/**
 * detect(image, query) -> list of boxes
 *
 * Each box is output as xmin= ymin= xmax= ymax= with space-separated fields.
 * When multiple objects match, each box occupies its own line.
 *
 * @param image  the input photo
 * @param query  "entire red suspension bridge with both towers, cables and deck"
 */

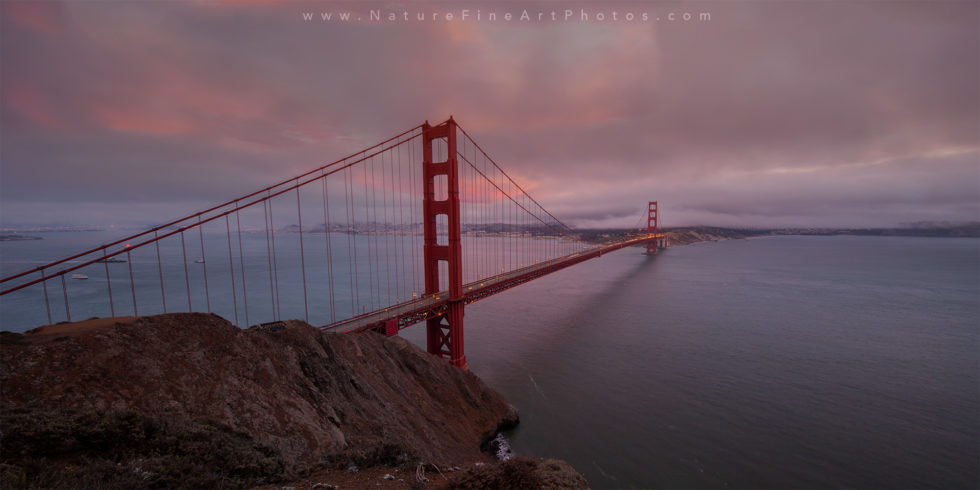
xmin=0 ymin=118 xmax=669 ymax=368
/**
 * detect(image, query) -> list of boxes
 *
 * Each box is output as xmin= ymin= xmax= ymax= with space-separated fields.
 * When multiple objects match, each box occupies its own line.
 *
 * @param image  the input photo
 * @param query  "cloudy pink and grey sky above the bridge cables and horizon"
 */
xmin=0 ymin=0 xmax=980 ymax=227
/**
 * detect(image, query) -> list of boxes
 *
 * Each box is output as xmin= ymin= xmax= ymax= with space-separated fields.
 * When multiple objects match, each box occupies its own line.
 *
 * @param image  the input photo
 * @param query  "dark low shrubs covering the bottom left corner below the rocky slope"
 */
xmin=0 ymin=409 xmax=302 ymax=488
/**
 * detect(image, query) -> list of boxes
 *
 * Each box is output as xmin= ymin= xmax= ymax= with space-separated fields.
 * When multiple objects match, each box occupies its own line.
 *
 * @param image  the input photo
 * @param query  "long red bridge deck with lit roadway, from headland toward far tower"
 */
xmin=319 ymin=233 xmax=666 ymax=334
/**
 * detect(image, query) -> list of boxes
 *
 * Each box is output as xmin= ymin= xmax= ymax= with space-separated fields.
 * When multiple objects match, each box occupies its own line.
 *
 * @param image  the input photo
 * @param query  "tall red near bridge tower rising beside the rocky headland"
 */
xmin=422 ymin=117 xmax=468 ymax=369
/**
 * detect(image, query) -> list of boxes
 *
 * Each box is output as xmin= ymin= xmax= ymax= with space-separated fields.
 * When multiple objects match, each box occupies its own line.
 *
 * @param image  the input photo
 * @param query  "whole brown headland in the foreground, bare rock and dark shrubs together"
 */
xmin=0 ymin=313 xmax=517 ymax=488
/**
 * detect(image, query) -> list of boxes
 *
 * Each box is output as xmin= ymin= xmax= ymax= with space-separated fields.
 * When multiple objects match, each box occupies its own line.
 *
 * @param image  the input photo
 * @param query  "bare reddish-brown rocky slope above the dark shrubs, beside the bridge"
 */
xmin=0 ymin=313 xmax=517 ymax=480
